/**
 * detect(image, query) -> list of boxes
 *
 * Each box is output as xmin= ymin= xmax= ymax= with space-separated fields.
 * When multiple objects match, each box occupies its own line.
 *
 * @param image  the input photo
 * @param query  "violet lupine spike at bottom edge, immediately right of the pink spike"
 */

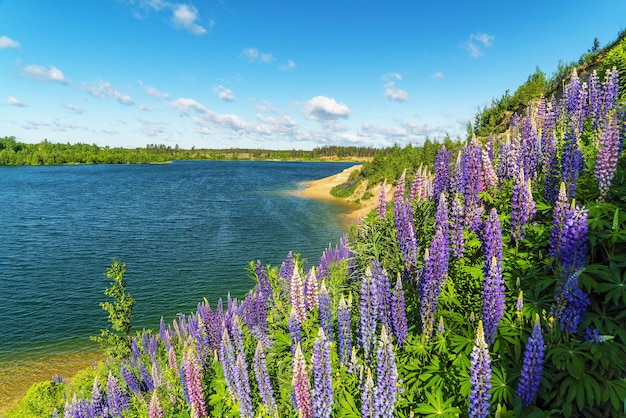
xmin=312 ymin=328 xmax=333 ymax=418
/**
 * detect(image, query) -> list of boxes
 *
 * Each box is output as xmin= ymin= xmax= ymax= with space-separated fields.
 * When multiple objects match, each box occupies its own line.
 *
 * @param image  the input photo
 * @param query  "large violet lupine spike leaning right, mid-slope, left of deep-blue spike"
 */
xmin=418 ymin=228 xmax=450 ymax=339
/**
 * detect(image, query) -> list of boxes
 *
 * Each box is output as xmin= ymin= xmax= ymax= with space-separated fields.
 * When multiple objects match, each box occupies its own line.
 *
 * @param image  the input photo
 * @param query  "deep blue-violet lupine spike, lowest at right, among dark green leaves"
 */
xmin=517 ymin=315 xmax=545 ymax=406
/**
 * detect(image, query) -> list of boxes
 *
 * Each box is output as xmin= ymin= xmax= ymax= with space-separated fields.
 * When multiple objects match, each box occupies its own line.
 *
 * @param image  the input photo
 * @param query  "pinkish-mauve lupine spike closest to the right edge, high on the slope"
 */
xmin=594 ymin=114 xmax=620 ymax=200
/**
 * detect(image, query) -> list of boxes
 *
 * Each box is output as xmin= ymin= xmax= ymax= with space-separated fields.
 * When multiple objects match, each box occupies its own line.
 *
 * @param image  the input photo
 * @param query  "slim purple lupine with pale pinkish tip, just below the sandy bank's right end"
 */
xmin=393 ymin=172 xmax=417 ymax=267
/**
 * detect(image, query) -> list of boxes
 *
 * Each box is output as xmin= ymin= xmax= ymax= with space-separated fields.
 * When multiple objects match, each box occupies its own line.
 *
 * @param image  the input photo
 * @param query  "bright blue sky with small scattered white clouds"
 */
xmin=0 ymin=0 xmax=626 ymax=149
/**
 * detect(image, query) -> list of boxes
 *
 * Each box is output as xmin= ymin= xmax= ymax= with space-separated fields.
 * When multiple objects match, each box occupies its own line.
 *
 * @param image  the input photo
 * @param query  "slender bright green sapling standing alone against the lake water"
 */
xmin=91 ymin=259 xmax=135 ymax=359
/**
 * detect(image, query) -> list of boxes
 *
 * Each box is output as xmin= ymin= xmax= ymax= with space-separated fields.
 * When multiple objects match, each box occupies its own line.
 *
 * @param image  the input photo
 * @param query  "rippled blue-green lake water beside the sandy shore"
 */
xmin=0 ymin=161 xmax=351 ymax=403
